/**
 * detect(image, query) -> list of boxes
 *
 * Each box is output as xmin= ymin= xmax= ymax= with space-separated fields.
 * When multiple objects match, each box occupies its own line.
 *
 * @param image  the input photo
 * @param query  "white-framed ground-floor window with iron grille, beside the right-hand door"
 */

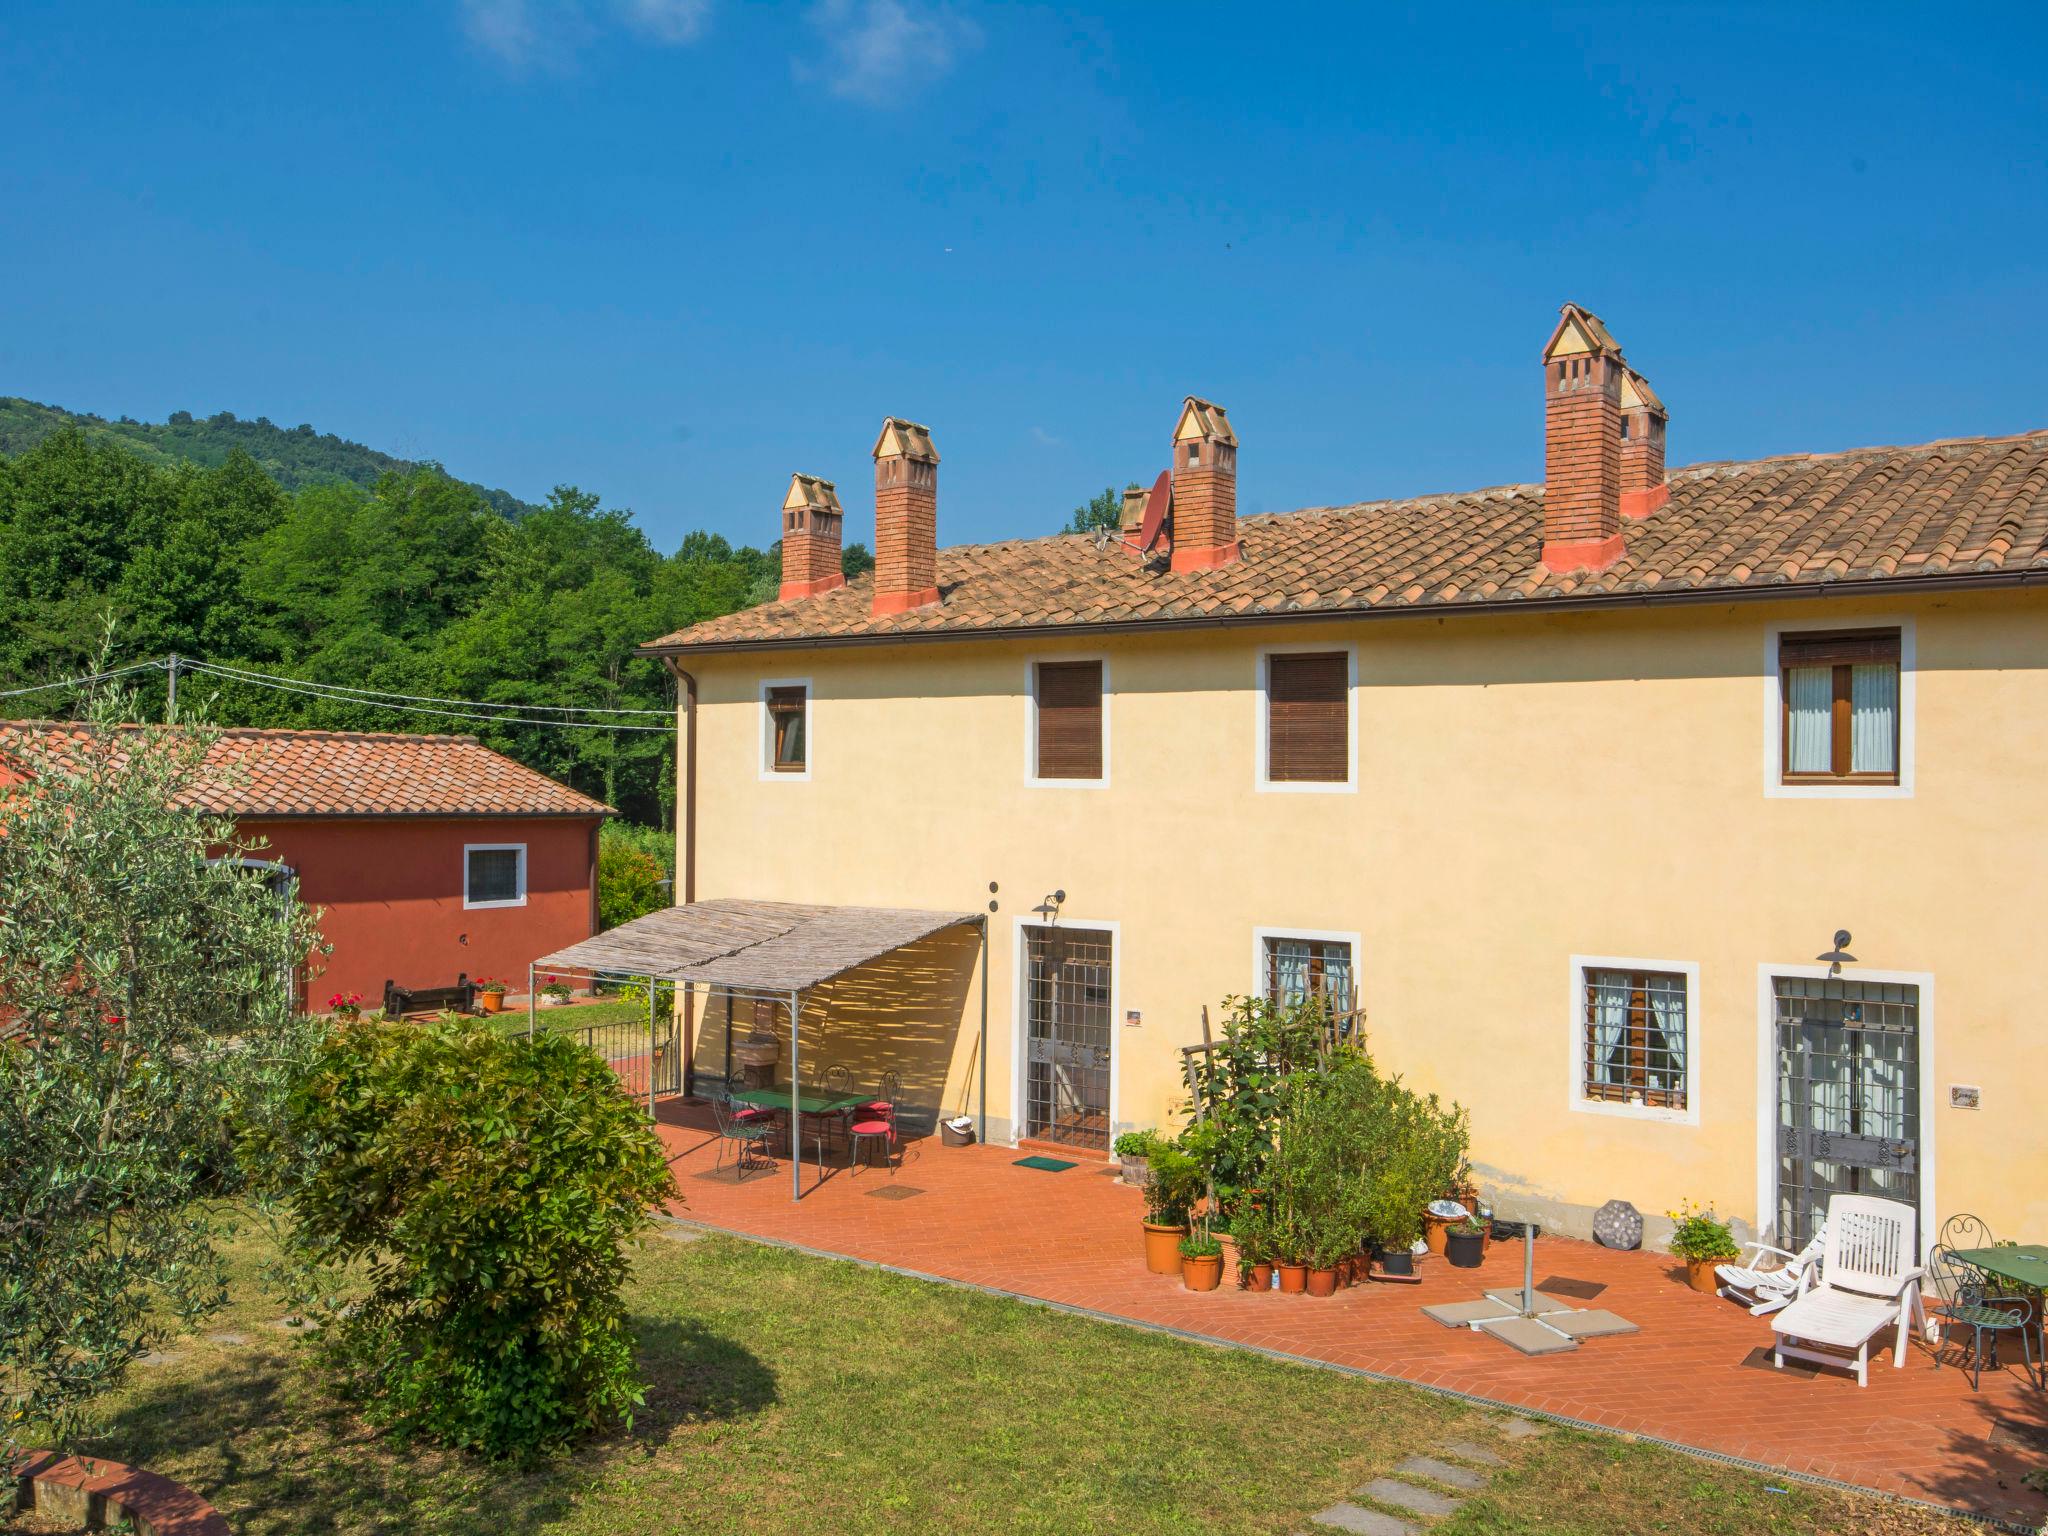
xmin=1571 ymin=954 xmax=1700 ymax=1124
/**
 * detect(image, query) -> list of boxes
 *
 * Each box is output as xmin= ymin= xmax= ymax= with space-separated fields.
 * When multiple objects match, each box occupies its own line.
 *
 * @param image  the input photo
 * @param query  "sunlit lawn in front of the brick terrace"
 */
xmin=19 ymin=1227 xmax=1974 ymax=1536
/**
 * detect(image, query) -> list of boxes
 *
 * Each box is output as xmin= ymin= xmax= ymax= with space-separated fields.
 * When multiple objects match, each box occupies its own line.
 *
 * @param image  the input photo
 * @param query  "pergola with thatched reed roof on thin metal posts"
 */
xmin=526 ymin=899 xmax=989 ymax=1200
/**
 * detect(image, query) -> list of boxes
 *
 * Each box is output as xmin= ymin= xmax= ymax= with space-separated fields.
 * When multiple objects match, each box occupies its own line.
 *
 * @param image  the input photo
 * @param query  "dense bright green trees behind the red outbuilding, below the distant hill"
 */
xmin=0 ymin=428 xmax=866 ymax=825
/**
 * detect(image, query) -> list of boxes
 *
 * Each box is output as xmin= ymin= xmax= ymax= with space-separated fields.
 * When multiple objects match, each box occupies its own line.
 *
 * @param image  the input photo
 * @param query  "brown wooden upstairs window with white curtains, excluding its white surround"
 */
xmin=1778 ymin=629 xmax=1898 ymax=784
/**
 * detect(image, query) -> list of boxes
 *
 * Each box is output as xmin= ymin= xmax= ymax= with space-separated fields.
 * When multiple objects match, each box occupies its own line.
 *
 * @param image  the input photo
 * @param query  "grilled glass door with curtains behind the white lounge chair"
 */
xmin=1772 ymin=977 xmax=1921 ymax=1251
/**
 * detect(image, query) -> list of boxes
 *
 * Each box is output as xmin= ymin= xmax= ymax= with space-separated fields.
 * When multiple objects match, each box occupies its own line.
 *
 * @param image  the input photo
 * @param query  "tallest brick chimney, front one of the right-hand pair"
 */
xmin=1542 ymin=303 xmax=1628 ymax=571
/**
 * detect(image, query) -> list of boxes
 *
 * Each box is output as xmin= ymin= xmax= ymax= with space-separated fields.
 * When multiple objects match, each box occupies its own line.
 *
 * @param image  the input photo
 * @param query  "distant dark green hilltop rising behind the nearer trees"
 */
xmin=0 ymin=395 xmax=532 ymax=518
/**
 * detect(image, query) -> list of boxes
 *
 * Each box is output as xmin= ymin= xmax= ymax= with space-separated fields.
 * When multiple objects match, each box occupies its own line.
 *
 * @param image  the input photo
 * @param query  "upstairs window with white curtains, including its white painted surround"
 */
xmin=1763 ymin=618 xmax=1915 ymax=801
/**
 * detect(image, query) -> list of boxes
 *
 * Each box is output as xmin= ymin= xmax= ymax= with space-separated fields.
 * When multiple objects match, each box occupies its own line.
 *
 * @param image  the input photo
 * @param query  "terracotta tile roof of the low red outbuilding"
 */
xmin=0 ymin=721 xmax=612 ymax=819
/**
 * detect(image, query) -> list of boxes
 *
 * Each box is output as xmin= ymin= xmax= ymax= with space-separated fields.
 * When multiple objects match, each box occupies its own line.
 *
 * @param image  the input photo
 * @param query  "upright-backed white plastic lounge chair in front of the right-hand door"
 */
xmin=1772 ymin=1194 xmax=1927 ymax=1386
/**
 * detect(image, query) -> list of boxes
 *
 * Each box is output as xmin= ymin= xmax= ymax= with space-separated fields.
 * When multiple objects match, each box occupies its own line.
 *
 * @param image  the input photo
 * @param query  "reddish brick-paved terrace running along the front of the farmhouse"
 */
xmin=662 ymin=1102 xmax=2048 ymax=1522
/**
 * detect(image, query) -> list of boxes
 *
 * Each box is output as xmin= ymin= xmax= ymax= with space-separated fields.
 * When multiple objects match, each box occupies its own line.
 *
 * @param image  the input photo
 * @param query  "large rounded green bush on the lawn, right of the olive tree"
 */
xmin=281 ymin=1020 xmax=674 ymax=1458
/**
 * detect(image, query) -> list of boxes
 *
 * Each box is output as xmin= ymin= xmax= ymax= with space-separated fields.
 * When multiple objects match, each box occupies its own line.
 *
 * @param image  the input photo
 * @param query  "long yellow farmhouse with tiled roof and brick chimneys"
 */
xmin=647 ymin=305 xmax=2048 ymax=1245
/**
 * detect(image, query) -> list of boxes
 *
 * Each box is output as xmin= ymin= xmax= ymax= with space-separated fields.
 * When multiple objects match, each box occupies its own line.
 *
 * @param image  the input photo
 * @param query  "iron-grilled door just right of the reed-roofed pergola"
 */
xmin=1024 ymin=928 xmax=1112 ymax=1151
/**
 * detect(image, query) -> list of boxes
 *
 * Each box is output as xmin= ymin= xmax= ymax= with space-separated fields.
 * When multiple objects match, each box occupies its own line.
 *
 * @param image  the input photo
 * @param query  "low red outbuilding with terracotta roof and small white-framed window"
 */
xmin=0 ymin=721 xmax=612 ymax=1012
